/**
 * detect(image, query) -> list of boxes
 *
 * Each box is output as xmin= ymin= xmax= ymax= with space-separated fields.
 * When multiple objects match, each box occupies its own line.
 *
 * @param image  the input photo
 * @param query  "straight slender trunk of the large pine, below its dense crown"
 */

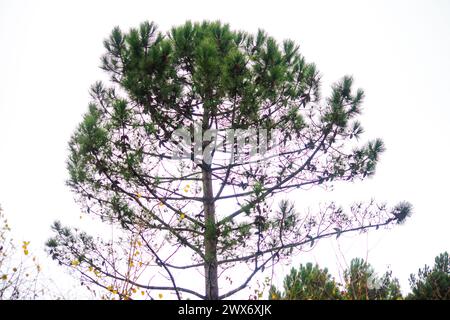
xmin=202 ymin=166 xmax=219 ymax=300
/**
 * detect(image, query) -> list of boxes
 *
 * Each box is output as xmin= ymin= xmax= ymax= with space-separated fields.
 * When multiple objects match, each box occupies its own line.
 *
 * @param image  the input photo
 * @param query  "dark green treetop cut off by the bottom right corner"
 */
xmin=408 ymin=252 xmax=450 ymax=300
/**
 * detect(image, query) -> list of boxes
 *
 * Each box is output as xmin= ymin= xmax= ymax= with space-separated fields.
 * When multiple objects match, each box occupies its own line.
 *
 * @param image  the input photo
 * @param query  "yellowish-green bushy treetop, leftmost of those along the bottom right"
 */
xmin=269 ymin=263 xmax=341 ymax=300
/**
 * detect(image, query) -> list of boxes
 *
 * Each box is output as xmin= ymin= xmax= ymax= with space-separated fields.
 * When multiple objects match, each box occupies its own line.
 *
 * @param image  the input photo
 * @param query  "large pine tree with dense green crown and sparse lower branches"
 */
xmin=48 ymin=22 xmax=410 ymax=299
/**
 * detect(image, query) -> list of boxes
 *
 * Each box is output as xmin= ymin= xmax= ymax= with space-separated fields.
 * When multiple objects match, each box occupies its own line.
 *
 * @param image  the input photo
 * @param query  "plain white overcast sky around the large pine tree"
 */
xmin=0 ymin=0 xmax=450 ymax=298
